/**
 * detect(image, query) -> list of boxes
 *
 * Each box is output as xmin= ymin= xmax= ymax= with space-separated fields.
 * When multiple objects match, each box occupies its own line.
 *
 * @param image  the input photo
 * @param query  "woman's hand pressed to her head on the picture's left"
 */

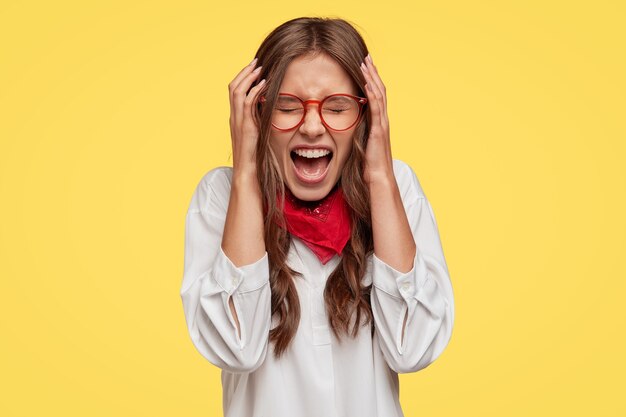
xmin=228 ymin=58 xmax=265 ymax=175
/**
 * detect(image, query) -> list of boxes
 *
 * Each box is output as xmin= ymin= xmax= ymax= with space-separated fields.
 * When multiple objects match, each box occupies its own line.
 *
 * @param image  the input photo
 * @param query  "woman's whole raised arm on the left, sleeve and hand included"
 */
xmin=181 ymin=57 xmax=271 ymax=372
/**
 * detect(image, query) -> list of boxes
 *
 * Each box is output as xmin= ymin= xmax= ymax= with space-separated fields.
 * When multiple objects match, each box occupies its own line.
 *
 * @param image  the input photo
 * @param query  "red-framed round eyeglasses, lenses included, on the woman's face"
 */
xmin=259 ymin=93 xmax=367 ymax=131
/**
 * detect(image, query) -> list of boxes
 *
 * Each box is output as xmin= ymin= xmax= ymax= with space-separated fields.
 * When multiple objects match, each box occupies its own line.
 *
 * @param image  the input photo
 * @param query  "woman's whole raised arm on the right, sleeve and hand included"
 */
xmin=361 ymin=55 xmax=454 ymax=373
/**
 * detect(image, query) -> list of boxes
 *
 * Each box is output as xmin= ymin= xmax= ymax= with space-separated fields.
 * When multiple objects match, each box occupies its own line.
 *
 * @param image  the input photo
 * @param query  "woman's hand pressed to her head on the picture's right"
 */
xmin=361 ymin=54 xmax=394 ymax=184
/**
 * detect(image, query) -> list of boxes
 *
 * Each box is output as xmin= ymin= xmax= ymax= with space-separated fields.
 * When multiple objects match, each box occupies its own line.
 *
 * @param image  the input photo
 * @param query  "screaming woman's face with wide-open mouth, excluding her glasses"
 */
xmin=270 ymin=54 xmax=358 ymax=201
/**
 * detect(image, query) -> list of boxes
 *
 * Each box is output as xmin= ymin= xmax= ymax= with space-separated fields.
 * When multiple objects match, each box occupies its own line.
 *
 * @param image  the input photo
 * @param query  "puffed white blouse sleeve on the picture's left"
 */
xmin=180 ymin=167 xmax=271 ymax=373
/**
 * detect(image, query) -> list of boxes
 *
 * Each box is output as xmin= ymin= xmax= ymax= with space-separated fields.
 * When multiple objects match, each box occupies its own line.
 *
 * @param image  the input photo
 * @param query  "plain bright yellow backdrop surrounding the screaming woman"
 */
xmin=0 ymin=0 xmax=626 ymax=417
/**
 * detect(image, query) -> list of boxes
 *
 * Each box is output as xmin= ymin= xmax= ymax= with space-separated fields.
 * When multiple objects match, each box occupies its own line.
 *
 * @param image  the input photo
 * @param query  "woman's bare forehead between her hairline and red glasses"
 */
xmin=280 ymin=53 xmax=357 ymax=99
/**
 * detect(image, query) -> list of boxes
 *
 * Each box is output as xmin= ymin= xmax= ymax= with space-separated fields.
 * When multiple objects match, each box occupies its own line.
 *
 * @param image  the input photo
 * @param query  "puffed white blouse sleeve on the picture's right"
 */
xmin=371 ymin=160 xmax=454 ymax=373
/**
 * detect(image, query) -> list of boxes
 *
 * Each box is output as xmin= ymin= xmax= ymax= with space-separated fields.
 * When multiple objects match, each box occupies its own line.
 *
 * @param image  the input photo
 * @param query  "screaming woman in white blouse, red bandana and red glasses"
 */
xmin=181 ymin=18 xmax=454 ymax=417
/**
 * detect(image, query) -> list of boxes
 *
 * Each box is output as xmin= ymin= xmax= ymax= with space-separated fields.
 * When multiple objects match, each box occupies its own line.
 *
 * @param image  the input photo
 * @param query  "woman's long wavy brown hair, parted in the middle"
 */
xmin=255 ymin=17 xmax=374 ymax=357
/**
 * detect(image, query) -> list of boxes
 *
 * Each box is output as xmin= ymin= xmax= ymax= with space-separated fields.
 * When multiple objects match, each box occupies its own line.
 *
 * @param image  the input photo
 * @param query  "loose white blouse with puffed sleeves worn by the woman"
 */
xmin=180 ymin=160 xmax=454 ymax=417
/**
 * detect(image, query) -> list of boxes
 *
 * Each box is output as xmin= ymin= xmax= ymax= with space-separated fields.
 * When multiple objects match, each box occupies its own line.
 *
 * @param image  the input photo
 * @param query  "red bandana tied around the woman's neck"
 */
xmin=276 ymin=185 xmax=351 ymax=264
